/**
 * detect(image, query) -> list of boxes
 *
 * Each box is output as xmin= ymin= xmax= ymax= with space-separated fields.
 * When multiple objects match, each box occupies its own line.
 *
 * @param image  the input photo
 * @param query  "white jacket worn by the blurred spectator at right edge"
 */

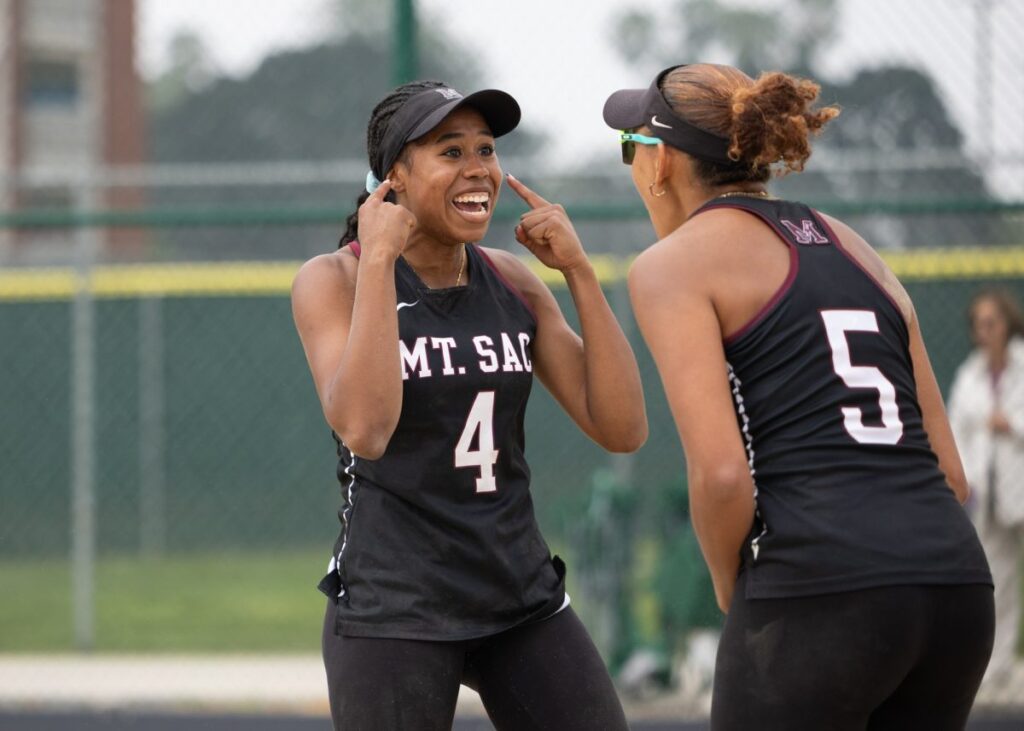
xmin=949 ymin=338 xmax=1024 ymax=526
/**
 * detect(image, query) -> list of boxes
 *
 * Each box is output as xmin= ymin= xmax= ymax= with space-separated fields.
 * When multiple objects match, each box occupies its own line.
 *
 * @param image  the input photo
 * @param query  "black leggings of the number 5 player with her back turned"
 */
xmin=711 ymin=577 xmax=994 ymax=731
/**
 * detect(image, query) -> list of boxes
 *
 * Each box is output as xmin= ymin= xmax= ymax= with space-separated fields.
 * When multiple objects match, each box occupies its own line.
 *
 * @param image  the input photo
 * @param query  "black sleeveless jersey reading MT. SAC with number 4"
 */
xmin=321 ymin=244 xmax=565 ymax=640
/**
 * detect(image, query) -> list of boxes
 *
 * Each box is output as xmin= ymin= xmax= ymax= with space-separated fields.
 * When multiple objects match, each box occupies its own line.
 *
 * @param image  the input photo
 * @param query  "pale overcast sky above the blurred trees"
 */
xmin=139 ymin=0 xmax=1024 ymax=194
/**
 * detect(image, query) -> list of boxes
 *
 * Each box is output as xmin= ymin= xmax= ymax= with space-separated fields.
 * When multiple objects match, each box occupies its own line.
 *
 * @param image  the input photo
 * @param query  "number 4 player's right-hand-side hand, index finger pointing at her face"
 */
xmin=507 ymin=175 xmax=589 ymax=272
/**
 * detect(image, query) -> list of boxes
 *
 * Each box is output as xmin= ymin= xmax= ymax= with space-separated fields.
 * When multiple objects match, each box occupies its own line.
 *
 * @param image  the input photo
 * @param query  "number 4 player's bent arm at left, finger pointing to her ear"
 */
xmin=292 ymin=181 xmax=415 ymax=460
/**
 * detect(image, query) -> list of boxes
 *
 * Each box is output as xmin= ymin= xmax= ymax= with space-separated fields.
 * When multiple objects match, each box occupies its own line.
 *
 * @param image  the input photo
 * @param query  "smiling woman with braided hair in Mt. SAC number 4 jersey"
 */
xmin=292 ymin=82 xmax=647 ymax=731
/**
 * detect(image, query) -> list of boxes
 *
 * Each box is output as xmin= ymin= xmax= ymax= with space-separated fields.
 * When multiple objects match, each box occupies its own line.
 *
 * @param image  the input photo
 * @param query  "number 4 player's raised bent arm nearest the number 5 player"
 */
xmin=493 ymin=176 xmax=647 ymax=452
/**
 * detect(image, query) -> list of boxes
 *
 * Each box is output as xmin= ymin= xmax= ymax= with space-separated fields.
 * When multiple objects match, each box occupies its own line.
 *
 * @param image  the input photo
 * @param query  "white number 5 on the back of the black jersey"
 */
xmin=821 ymin=309 xmax=903 ymax=444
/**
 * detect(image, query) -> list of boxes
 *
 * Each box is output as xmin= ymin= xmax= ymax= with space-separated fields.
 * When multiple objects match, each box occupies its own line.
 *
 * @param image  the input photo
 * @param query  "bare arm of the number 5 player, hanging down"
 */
xmin=629 ymin=237 xmax=754 ymax=612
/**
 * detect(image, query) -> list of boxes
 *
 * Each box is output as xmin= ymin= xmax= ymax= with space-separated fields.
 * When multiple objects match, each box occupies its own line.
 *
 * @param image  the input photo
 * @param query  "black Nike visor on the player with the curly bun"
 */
xmin=604 ymin=65 xmax=741 ymax=167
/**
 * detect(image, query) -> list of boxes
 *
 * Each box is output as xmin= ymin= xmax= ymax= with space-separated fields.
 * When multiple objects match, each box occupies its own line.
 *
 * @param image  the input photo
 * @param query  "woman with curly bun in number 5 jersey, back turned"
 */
xmin=604 ymin=65 xmax=993 ymax=731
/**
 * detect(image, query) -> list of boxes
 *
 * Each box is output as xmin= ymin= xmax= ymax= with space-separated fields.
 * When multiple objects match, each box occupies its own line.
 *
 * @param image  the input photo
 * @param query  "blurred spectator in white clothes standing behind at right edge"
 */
xmin=949 ymin=289 xmax=1024 ymax=689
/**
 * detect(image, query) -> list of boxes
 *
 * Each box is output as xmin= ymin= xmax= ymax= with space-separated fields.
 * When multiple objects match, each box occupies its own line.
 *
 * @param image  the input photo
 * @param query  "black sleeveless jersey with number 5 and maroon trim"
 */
xmin=700 ymin=198 xmax=991 ymax=598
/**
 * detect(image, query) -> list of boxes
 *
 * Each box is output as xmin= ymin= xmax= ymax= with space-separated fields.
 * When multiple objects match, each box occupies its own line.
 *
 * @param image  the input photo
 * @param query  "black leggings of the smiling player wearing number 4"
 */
xmin=323 ymin=601 xmax=628 ymax=731
